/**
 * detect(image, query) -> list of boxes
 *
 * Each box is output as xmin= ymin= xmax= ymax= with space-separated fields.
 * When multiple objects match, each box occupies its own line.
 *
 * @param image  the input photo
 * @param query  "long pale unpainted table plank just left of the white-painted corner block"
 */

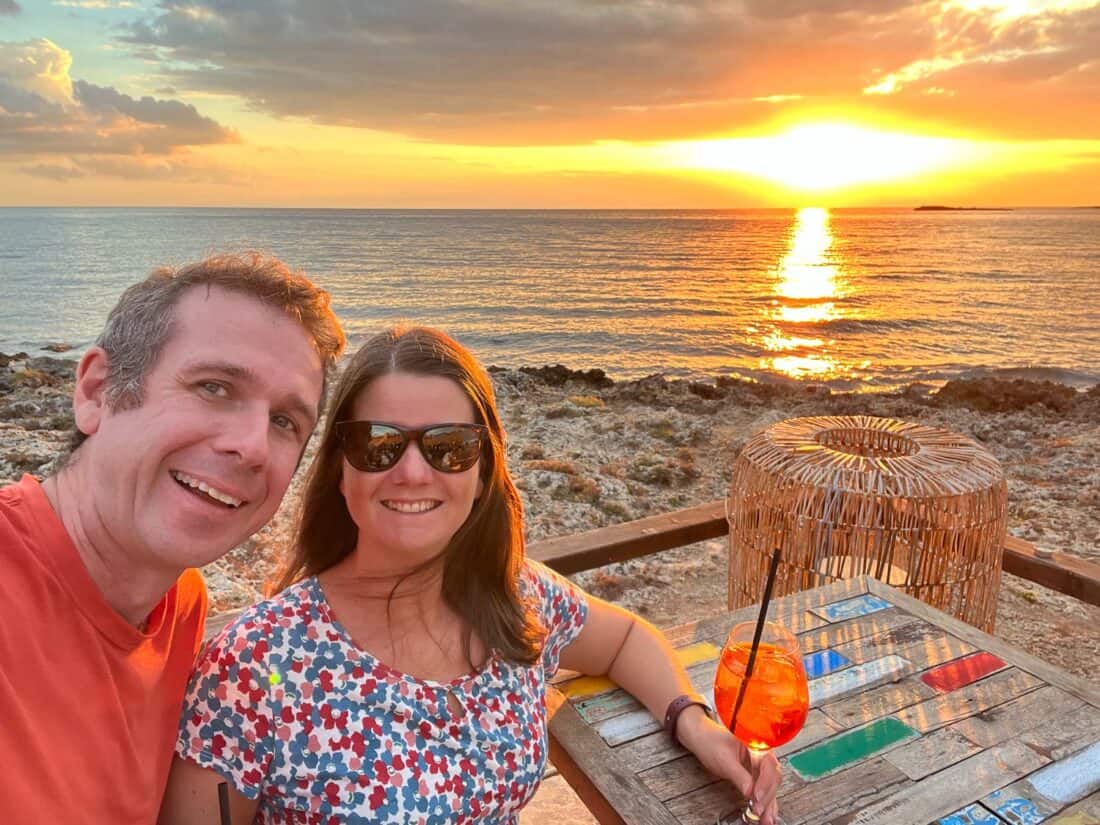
xmin=828 ymin=743 xmax=1049 ymax=825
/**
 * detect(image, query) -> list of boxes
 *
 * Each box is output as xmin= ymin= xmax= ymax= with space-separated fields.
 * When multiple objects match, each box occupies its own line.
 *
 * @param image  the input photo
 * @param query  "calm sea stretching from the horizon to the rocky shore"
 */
xmin=0 ymin=208 xmax=1100 ymax=392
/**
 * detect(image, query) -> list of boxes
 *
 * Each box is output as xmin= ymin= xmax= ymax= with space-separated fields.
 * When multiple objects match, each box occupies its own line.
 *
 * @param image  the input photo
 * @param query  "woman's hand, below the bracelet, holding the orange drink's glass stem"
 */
xmin=677 ymin=706 xmax=781 ymax=825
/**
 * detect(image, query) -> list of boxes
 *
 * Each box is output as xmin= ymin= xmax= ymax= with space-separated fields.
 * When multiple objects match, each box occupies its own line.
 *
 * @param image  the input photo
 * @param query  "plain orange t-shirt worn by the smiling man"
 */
xmin=0 ymin=475 xmax=206 ymax=825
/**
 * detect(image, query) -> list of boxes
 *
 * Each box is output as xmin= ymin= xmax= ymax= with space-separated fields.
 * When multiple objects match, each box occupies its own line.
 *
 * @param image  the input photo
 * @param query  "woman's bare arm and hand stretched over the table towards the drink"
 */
xmin=561 ymin=595 xmax=780 ymax=825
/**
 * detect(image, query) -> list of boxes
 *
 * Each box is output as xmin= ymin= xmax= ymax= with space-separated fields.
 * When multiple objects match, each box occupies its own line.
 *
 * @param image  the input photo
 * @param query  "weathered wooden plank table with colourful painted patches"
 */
xmin=550 ymin=576 xmax=1100 ymax=825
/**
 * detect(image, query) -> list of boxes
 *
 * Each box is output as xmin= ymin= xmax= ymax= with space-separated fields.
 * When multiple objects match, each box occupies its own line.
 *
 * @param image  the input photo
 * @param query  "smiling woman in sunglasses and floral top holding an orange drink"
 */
xmin=161 ymin=328 xmax=779 ymax=825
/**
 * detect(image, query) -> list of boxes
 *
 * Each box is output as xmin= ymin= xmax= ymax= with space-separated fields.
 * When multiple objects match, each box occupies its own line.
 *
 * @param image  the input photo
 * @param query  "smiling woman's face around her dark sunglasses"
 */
xmin=340 ymin=372 xmax=483 ymax=572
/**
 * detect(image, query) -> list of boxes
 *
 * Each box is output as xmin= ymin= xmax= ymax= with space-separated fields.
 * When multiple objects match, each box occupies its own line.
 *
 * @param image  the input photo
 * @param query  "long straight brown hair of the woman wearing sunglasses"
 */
xmin=273 ymin=327 xmax=542 ymax=664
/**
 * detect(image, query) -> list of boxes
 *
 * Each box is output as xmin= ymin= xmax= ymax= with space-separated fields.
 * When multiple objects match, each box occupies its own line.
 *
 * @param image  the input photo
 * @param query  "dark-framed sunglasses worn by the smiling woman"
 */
xmin=336 ymin=421 xmax=488 ymax=473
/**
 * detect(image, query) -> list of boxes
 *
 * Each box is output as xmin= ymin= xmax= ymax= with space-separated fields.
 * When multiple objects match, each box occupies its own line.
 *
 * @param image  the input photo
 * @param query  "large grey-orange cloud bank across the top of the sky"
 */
xmin=113 ymin=0 xmax=1100 ymax=144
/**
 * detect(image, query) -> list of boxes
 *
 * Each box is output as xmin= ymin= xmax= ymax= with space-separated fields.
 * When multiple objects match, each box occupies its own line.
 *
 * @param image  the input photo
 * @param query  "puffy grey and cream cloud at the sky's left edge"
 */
xmin=0 ymin=40 xmax=239 ymax=180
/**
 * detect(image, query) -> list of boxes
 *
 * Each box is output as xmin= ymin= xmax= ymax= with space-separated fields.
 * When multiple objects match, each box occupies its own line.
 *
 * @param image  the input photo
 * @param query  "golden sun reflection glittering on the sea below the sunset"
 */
xmin=760 ymin=207 xmax=846 ymax=378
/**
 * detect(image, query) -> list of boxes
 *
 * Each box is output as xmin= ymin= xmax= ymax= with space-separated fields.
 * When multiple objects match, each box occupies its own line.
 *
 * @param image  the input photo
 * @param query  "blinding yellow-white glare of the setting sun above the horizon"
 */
xmin=678 ymin=123 xmax=972 ymax=191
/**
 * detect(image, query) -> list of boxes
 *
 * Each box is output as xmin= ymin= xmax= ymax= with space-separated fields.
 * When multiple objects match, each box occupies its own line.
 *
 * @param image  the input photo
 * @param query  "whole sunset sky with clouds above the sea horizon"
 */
xmin=0 ymin=0 xmax=1100 ymax=208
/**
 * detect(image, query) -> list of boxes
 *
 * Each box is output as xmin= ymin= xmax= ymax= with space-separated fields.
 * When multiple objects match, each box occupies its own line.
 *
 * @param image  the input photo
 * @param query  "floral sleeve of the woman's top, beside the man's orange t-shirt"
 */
xmin=176 ymin=612 xmax=275 ymax=799
